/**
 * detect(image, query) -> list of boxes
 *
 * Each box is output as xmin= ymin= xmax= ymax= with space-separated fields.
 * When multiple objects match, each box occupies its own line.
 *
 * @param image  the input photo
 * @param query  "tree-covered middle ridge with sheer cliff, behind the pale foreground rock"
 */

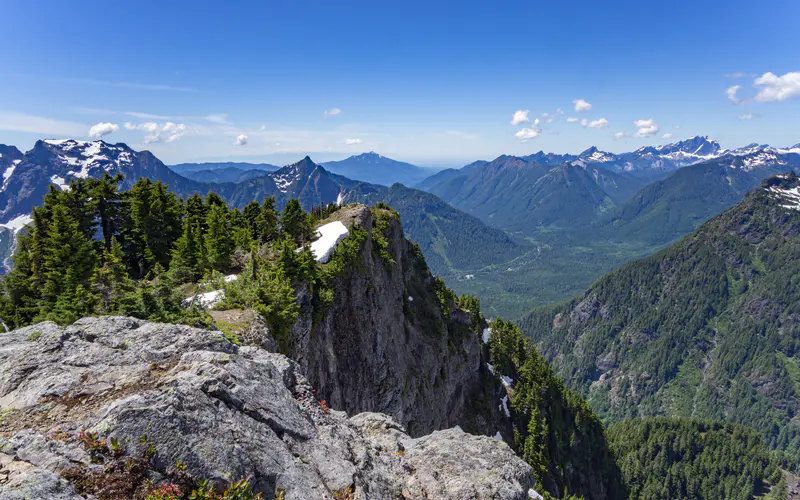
xmin=0 ymin=175 xmax=625 ymax=500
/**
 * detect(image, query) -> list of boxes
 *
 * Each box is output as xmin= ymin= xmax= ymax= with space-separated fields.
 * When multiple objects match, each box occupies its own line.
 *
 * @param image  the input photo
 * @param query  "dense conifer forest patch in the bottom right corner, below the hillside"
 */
xmin=608 ymin=418 xmax=785 ymax=500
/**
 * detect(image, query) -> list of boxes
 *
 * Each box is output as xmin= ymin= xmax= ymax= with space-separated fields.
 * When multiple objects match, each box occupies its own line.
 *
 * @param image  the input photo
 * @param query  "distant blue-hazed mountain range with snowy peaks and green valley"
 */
xmin=0 ymin=137 xmax=800 ymax=317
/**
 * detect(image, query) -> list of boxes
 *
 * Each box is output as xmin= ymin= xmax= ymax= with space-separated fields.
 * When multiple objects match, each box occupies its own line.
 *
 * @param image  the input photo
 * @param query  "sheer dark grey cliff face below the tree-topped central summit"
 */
xmin=290 ymin=205 xmax=510 ymax=436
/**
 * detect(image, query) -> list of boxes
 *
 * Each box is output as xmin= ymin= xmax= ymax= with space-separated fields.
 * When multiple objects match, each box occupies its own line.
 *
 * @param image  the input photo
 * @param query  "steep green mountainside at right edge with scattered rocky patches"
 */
xmin=520 ymin=173 xmax=800 ymax=463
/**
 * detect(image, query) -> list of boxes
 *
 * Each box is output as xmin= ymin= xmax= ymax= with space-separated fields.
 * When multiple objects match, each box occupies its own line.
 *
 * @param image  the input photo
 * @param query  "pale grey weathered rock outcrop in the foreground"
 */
xmin=0 ymin=317 xmax=533 ymax=500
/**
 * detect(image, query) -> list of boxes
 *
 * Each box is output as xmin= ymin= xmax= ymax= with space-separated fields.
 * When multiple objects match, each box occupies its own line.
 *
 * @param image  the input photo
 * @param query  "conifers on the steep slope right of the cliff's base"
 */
xmin=489 ymin=320 xmax=625 ymax=499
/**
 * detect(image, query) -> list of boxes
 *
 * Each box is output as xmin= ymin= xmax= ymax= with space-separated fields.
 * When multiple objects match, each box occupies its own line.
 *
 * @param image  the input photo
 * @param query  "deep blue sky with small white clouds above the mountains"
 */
xmin=0 ymin=0 xmax=800 ymax=165
